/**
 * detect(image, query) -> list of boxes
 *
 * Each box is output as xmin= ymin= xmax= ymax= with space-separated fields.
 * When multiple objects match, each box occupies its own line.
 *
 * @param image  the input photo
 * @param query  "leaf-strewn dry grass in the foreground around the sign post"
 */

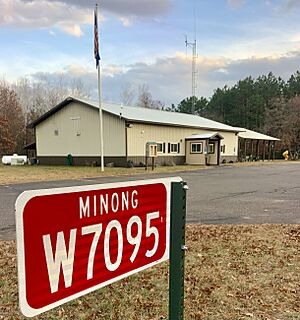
xmin=0 ymin=225 xmax=300 ymax=320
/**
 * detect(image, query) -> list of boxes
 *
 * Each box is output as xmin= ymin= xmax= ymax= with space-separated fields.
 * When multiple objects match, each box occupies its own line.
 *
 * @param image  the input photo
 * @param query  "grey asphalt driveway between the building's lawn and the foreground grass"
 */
xmin=0 ymin=163 xmax=300 ymax=239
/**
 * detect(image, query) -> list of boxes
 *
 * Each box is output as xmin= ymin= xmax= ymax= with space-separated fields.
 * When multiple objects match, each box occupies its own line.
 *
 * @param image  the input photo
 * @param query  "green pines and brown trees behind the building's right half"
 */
xmin=168 ymin=71 xmax=300 ymax=159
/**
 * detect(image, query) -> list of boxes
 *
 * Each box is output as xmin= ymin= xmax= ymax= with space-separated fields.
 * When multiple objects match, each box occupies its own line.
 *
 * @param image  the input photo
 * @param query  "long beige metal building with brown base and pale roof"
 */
xmin=31 ymin=97 xmax=241 ymax=166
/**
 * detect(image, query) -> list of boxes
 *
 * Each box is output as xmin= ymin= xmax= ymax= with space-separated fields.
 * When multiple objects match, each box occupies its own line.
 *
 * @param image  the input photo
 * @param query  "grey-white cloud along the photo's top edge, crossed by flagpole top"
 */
xmin=0 ymin=0 xmax=171 ymax=37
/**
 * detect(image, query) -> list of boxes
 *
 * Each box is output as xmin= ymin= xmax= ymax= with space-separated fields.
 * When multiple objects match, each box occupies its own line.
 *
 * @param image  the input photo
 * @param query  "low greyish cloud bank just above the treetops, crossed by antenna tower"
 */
xmin=26 ymin=52 xmax=300 ymax=105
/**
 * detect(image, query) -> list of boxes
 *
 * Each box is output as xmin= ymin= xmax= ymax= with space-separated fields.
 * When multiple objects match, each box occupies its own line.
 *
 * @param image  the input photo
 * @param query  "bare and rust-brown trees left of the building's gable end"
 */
xmin=0 ymin=76 xmax=90 ymax=156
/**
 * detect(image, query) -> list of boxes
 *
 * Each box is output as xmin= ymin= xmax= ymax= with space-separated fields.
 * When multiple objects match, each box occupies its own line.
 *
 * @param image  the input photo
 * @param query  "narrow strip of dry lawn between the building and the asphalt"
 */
xmin=0 ymin=164 xmax=208 ymax=185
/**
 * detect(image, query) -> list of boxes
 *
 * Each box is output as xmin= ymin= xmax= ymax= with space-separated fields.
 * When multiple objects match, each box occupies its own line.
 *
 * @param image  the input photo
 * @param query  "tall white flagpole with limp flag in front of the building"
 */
xmin=95 ymin=4 xmax=104 ymax=172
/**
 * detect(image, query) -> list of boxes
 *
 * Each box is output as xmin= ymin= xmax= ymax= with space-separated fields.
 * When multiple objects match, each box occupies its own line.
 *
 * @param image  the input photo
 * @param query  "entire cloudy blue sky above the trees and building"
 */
xmin=0 ymin=0 xmax=300 ymax=105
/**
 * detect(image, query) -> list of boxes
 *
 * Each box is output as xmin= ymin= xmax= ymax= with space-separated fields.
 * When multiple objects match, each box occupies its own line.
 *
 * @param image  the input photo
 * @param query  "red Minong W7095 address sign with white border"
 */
xmin=16 ymin=178 xmax=181 ymax=317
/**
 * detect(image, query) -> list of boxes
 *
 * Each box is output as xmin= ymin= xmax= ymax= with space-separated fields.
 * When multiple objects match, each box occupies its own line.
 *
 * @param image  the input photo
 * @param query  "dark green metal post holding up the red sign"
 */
xmin=169 ymin=181 xmax=188 ymax=320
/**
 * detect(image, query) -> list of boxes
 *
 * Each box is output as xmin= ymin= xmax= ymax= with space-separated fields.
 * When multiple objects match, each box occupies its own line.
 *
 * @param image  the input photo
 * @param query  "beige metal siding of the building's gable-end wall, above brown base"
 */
xmin=36 ymin=102 xmax=126 ymax=156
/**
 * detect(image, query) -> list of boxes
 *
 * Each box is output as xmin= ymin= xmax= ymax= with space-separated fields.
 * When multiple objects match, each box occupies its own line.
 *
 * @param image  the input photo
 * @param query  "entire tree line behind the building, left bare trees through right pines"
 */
xmin=0 ymin=71 xmax=300 ymax=158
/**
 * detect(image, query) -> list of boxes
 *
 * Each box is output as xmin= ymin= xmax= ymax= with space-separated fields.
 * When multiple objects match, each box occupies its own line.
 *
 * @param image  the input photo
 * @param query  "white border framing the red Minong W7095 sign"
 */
xmin=15 ymin=177 xmax=182 ymax=317
